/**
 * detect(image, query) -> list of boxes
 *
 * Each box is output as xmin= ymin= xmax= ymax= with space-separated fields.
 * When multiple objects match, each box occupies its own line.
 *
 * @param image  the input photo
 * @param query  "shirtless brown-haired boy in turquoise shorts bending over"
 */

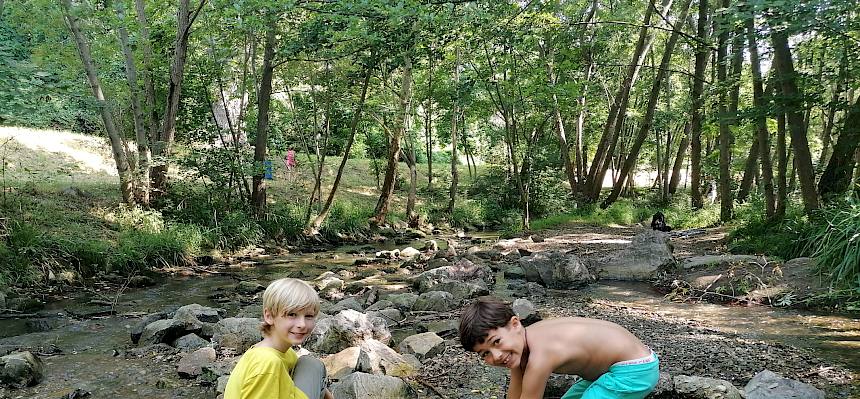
xmin=460 ymin=297 xmax=660 ymax=399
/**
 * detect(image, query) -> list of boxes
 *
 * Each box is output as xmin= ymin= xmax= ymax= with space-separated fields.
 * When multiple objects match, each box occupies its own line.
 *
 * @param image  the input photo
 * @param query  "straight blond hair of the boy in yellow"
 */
xmin=260 ymin=278 xmax=320 ymax=335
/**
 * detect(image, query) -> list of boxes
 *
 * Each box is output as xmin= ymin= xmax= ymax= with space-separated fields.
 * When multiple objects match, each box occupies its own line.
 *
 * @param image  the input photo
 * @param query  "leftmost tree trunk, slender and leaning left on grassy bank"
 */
xmin=61 ymin=0 xmax=134 ymax=204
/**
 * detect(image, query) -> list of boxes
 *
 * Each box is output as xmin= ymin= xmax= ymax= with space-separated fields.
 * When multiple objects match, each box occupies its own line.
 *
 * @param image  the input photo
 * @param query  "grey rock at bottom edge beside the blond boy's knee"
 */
xmin=331 ymin=373 xmax=416 ymax=399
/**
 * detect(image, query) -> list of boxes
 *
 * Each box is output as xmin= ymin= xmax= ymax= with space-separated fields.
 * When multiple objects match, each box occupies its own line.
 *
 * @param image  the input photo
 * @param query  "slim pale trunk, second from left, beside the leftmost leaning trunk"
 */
xmin=114 ymin=1 xmax=152 ymax=208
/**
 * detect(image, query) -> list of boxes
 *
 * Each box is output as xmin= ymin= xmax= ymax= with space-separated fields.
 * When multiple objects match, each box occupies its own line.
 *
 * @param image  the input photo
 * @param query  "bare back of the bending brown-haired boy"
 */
xmin=521 ymin=317 xmax=651 ymax=381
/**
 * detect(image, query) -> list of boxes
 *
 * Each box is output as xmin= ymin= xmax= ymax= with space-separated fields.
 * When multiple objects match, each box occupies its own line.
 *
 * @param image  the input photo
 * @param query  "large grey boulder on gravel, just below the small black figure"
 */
xmin=594 ymin=230 xmax=675 ymax=281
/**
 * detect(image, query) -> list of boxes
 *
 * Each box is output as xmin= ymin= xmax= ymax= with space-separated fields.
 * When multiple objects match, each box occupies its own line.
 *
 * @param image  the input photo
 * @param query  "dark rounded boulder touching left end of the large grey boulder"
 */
xmin=518 ymin=251 xmax=593 ymax=289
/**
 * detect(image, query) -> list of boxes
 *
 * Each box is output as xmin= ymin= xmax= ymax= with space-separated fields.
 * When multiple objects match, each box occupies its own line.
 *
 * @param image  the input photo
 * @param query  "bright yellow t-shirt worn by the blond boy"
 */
xmin=224 ymin=346 xmax=308 ymax=399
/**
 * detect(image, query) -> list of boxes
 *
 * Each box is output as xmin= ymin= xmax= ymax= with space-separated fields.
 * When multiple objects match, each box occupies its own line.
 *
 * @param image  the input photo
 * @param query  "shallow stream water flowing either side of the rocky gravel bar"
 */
xmin=0 ymin=245 xmax=860 ymax=399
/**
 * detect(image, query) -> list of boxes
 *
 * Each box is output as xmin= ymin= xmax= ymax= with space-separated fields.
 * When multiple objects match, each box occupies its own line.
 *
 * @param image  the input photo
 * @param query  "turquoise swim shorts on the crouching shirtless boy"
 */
xmin=561 ymin=352 xmax=660 ymax=399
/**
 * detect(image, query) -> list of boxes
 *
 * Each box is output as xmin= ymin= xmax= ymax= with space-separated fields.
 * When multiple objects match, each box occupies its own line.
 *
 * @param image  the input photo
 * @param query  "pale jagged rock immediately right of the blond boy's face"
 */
xmin=305 ymin=309 xmax=391 ymax=353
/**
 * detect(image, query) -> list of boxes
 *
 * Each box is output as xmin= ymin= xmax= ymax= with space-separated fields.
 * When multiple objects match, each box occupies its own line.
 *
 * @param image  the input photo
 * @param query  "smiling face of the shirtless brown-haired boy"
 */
xmin=473 ymin=316 xmax=528 ymax=369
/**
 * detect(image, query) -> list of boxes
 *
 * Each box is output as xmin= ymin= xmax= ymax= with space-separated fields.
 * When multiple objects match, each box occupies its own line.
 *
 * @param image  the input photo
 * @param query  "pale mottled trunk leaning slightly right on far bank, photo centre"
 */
xmin=370 ymin=53 xmax=412 ymax=226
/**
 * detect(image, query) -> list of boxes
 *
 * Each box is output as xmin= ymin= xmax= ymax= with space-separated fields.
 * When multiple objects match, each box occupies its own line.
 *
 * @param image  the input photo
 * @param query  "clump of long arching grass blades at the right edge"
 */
xmin=806 ymin=200 xmax=860 ymax=290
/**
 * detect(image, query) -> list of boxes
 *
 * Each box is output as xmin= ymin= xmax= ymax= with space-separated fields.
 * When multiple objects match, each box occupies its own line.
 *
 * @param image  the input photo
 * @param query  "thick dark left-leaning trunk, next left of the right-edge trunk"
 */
xmin=771 ymin=29 xmax=819 ymax=213
